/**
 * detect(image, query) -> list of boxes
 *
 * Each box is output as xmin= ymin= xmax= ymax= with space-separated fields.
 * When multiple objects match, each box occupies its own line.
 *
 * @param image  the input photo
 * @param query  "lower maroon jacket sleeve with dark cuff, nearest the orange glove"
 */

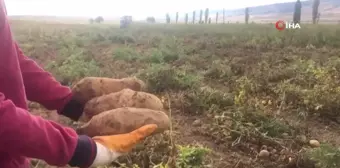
xmin=0 ymin=93 xmax=95 ymax=166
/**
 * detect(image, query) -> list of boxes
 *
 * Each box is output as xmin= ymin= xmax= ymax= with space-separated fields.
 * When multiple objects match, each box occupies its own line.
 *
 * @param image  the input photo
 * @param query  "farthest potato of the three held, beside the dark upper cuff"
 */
xmin=72 ymin=77 xmax=145 ymax=103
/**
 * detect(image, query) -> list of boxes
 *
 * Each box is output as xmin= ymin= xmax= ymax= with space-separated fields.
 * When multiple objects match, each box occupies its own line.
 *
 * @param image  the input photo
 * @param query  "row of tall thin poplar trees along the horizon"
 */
xmin=166 ymin=0 xmax=320 ymax=24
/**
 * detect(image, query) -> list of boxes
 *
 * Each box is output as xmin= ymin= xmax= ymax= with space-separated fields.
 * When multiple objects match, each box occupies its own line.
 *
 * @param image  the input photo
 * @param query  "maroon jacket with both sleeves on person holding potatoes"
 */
xmin=0 ymin=0 xmax=96 ymax=167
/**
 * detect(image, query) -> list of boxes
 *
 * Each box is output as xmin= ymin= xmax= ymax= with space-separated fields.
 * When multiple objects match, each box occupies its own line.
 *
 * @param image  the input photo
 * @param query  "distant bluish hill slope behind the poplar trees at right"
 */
xmin=181 ymin=0 xmax=340 ymax=23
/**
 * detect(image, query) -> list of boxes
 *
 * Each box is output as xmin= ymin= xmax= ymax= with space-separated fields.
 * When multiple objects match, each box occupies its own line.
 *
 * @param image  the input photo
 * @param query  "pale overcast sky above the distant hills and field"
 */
xmin=5 ymin=0 xmax=296 ymax=18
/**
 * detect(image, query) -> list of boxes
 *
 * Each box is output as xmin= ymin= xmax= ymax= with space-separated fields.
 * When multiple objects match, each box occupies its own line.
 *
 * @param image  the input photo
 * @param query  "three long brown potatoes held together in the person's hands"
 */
xmin=72 ymin=77 xmax=170 ymax=137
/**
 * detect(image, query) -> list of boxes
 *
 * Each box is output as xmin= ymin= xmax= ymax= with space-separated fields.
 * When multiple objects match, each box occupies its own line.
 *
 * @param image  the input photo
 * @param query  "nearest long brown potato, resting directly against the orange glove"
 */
xmin=76 ymin=107 xmax=170 ymax=137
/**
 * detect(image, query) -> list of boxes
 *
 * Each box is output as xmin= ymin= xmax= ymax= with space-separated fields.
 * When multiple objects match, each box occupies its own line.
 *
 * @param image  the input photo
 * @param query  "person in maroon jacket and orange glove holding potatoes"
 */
xmin=0 ymin=0 xmax=157 ymax=168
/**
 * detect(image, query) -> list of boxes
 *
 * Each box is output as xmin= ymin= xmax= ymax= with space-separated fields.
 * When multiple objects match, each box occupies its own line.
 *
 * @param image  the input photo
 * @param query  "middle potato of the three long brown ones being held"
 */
xmin=79 ymin=89 xmax=164 ymax=122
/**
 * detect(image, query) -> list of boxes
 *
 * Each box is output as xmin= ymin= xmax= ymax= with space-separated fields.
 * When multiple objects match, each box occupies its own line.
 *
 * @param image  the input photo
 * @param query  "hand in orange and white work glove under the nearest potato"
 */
xmin=87 ymin=124 xmax=157 ymax=167
